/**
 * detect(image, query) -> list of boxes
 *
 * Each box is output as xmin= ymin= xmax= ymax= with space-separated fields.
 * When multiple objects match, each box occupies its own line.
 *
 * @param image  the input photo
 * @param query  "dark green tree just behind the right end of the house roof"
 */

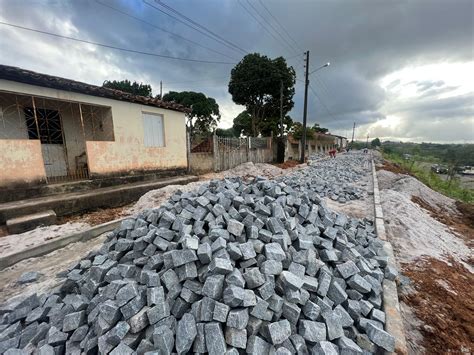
xmin=163 ymin=91 xmax=221 ymax=137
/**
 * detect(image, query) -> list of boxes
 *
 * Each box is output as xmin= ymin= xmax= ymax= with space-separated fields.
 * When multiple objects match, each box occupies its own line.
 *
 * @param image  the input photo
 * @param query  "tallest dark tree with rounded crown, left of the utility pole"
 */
xmin=229 ymin=53 xmax=296 ymax=136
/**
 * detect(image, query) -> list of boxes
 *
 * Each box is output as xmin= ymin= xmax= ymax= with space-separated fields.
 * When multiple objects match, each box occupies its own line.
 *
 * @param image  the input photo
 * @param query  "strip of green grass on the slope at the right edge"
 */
xmin=383 ymin=153 xmax=474 ymax=203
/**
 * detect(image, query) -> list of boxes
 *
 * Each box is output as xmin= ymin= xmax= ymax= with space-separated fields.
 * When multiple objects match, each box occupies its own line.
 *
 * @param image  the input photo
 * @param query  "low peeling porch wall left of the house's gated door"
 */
xmin=0 ymin=139 xmax=46 ymax=187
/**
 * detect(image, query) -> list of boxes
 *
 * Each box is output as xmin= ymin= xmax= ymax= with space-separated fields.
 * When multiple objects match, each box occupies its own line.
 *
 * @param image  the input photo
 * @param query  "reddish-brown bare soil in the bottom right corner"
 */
xmin=401 ymin=258 xmax=474 ymax=354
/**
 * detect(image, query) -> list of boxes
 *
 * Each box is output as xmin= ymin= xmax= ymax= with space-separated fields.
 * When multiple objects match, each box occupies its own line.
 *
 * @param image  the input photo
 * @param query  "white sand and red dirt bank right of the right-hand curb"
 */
xmin=378 ymin=163 xmax=474 ymax=354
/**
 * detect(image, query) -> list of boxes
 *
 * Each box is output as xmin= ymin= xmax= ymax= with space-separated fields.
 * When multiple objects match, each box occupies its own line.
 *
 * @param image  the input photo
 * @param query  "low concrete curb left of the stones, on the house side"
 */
xmin=0 ymin=218 xmax=127 ymax=270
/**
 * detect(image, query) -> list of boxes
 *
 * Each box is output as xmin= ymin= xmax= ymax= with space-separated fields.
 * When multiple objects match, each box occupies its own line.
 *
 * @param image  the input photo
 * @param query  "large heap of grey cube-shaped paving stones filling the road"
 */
xmin=0 ymin=155 xmax=396 ymax=354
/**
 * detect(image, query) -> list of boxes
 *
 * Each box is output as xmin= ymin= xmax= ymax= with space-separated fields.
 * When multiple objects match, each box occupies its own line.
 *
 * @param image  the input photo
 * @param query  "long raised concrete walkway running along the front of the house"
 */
xmin=0 ymin=175 xmax=198 ymax=224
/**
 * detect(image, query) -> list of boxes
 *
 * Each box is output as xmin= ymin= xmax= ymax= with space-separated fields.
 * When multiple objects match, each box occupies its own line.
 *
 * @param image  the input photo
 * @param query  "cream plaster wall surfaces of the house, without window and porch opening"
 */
xmin=0 ymin=80 xmax=187 ymax=183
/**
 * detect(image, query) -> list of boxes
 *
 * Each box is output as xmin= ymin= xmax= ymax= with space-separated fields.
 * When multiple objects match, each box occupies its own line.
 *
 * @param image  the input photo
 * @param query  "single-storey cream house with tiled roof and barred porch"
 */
xmin=0 ymin=65 xmax=188 ymax=188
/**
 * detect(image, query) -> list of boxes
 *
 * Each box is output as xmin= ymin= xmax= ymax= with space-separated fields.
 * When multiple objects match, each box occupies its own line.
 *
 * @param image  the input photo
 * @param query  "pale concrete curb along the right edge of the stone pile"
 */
xmin=372 ymin=159 xmax=408 ymax=354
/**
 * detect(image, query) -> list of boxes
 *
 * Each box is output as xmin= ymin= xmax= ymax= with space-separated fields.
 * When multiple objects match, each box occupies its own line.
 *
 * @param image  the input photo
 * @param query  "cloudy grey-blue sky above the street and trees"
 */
xmin=0 ymin=0 xmax=474 ymax=143
